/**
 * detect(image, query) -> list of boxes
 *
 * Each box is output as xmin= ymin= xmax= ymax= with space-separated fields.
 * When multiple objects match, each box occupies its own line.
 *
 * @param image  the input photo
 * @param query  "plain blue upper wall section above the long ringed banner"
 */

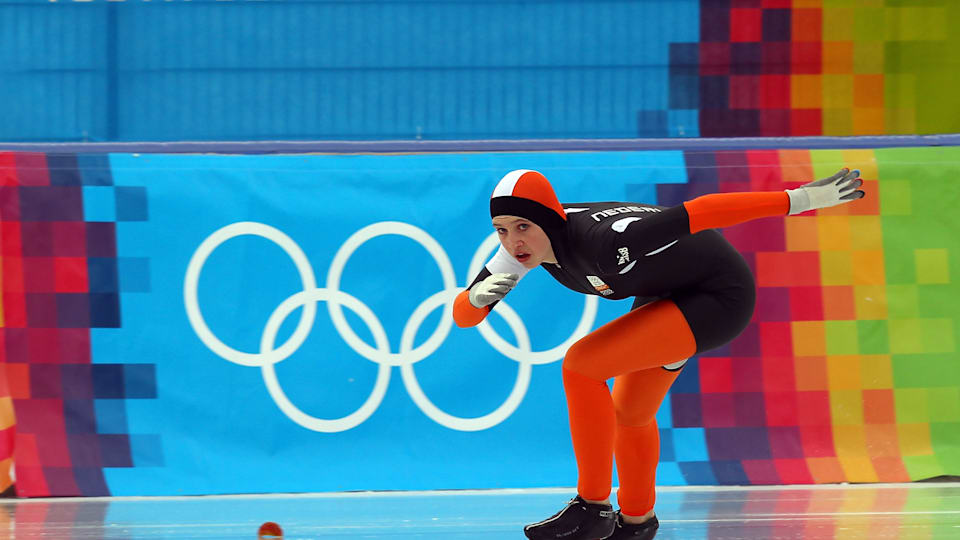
xmin=0 ymin=0 xmax=699 ymax=141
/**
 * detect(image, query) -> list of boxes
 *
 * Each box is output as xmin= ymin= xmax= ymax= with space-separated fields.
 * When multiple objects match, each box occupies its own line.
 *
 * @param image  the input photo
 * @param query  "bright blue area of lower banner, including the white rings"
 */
xmin=97 ymin=151 xmax=687 ymax=495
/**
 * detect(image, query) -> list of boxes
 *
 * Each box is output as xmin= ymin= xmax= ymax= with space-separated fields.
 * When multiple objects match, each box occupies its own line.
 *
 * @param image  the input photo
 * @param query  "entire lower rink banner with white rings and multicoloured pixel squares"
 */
xmin=0 ymin=147 xmax=960 ymax=497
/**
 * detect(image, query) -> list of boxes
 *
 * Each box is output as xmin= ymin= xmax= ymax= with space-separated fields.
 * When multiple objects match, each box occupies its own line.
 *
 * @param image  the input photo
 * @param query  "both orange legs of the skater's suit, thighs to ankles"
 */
xmin=563 ymin=300 xmax=697 ymax=516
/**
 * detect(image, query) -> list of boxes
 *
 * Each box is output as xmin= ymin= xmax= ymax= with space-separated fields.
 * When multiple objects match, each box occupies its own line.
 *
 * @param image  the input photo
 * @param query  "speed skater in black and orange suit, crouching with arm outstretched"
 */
xmin=453 ymin=169 xmax=864 ymax=540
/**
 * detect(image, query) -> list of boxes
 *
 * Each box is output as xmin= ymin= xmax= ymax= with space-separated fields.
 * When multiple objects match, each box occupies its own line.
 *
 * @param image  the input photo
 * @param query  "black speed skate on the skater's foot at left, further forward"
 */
xmin=523 ymin=495 xmax=617 ymax=540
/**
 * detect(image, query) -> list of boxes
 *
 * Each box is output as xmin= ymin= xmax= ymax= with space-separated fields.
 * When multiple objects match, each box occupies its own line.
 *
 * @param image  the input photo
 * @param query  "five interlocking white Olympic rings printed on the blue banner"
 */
xmin=183 ymin=221 xmax=597 ymax=433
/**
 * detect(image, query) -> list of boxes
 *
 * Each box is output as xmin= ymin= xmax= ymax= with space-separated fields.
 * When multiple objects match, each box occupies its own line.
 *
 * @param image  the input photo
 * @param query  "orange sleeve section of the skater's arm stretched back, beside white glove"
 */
xmin=683 ymin=191 xmax=790 ymax=234
